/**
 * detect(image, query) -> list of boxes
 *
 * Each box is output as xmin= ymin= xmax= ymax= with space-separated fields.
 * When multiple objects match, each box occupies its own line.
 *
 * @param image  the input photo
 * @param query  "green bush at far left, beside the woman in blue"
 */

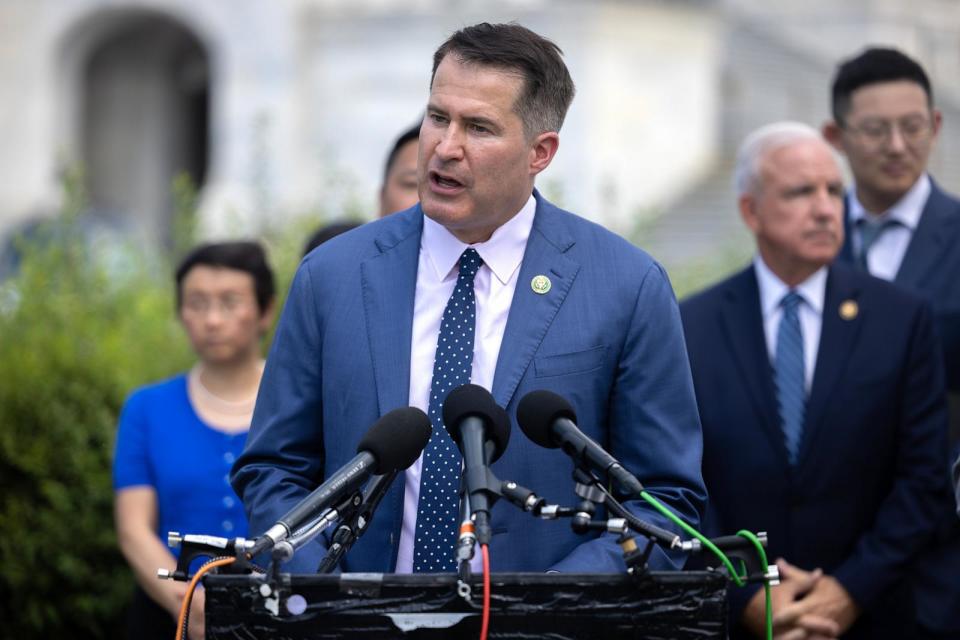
xmin=0 ymin=204 xmax=191 ymax=639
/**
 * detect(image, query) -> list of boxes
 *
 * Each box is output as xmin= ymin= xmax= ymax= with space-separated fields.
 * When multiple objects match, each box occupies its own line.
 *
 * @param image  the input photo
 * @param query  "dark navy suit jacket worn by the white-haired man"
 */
xmin=681 ymin=265 xmax=946 ymax=637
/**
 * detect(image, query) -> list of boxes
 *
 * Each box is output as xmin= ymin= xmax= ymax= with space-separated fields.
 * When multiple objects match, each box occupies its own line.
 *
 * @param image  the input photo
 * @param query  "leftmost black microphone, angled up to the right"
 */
xmin=249 ymin=407 xmax=432 ymax=557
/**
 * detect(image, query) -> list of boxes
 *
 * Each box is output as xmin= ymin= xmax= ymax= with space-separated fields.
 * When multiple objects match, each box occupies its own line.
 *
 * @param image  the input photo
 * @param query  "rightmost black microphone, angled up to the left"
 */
xmin=517 ymin=391 xmax=643 ymax=497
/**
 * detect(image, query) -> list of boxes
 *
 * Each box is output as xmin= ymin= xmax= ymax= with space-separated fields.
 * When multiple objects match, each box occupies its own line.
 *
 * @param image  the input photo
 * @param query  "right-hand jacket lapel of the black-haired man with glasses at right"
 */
xmin=894 ymin=184 xmax=960 ymax=289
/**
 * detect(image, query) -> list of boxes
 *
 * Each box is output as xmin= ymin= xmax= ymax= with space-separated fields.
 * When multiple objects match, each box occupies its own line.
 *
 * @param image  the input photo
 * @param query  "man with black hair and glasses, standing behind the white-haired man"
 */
xmin=824 ymin=48 xmax=960 ymax=638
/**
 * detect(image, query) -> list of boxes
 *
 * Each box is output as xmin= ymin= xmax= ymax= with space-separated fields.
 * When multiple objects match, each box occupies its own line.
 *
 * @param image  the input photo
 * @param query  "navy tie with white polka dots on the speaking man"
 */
xmin=413 ymin=249 xmax=483 ymax=573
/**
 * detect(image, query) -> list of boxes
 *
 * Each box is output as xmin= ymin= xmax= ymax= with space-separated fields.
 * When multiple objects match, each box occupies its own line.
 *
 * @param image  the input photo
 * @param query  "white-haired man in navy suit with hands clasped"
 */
xmin=681 ymin=123 xmax=946 ymax=638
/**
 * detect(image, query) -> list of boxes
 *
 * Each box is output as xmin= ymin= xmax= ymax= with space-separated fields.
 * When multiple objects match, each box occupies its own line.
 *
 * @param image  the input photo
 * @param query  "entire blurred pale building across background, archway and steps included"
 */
xmin=0 ymin=0 xmax=960 ymax=262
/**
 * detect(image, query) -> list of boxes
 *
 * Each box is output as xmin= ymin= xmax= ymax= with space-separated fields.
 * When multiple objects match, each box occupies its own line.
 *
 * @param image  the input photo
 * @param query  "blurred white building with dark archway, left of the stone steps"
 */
xmin=0 ymin=0 xmax=717 ymax=250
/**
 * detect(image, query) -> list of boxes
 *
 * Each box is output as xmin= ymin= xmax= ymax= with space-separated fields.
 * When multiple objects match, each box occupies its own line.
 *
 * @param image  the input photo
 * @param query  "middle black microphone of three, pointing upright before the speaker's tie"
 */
xmin=443 ymin=384 xmax=510 ymax=544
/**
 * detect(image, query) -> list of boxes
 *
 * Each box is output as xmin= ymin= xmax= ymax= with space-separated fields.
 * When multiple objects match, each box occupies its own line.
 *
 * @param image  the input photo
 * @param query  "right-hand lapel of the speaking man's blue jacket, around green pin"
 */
xmin=491 ymin=191 xmax=580 ymax=407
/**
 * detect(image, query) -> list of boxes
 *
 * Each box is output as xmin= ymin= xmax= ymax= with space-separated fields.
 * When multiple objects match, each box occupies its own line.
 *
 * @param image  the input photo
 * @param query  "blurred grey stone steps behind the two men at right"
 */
xmin=640 ymin=0 xmax=960 ymax=264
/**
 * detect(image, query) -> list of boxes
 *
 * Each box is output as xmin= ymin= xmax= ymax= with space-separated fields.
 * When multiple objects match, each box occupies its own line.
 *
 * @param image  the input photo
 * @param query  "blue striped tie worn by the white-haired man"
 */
xmin=774 ymin=291 xmax=807 ymax=464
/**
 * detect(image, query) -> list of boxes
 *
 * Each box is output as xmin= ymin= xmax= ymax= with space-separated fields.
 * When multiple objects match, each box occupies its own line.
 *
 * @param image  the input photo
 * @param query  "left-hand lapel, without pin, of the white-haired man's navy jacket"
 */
xmin=720 ymin=266 xmax=788 ymax=468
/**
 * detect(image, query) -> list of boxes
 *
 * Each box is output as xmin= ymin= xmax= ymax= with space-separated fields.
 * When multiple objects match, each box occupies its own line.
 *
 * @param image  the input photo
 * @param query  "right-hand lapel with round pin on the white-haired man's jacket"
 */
xmin=799 ymin=266 xmax=862 ymax=465
